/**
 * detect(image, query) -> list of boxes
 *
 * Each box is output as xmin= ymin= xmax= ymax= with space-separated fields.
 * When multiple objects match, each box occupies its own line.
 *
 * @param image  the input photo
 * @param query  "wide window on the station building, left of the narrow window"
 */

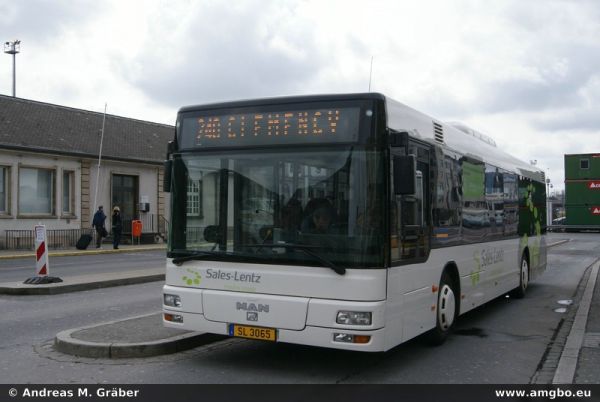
xmin=19 ymin=168 xmax=55 ymax=215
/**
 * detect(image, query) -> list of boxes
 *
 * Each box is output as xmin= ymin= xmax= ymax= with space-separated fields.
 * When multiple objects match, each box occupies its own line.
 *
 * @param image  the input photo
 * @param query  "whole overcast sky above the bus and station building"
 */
xmin=0 ymin=0 xmax=600 ymax=190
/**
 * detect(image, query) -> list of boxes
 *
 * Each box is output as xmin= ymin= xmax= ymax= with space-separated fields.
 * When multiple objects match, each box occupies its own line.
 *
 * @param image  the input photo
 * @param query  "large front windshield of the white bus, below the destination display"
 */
xmin=169 ymin=146 xmax=385 ymax=268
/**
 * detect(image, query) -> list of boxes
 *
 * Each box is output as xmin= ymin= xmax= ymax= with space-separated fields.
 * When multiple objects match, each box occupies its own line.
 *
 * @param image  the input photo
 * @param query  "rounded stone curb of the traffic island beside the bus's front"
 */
xmin=54 ymin=313 xmax=223 ymax=359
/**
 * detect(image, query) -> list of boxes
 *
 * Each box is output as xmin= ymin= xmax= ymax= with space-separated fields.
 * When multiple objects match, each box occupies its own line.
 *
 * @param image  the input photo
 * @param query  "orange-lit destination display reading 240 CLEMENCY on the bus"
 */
xmin=181 ymin=107 xmax=360 ymax=148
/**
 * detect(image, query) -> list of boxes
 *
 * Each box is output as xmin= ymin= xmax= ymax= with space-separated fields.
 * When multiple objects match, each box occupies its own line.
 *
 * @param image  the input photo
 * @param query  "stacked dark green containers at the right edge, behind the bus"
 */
xmin=565 ymin=154 xmax=600 ymax=230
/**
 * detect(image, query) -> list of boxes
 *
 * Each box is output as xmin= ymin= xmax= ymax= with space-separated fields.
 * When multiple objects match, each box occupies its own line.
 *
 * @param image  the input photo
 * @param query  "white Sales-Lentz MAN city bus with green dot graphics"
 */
xmin=163 ymin=93 xmax=546 ymax=352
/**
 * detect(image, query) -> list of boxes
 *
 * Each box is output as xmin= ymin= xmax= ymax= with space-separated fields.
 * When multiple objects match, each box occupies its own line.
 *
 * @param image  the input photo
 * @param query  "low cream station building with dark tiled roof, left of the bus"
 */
xmin=0 ymin=95 xmax=174 ymax=248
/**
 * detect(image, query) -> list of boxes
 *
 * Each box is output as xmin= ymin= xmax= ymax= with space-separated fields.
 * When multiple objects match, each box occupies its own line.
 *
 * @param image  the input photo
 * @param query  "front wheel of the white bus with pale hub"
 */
xmin=428 ymin=271 xmax=458 ymax=345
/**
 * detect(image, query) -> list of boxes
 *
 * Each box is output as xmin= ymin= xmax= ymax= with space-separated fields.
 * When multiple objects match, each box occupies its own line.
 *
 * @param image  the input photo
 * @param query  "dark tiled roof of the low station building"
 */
xmin=0 ymin=95 xmax=175 ymax=163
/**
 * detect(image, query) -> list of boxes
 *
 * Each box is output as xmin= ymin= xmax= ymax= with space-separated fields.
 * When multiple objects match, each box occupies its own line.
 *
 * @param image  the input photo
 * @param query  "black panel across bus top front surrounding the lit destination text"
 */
xmin=177 ymin=99 xmax=380 ymax=151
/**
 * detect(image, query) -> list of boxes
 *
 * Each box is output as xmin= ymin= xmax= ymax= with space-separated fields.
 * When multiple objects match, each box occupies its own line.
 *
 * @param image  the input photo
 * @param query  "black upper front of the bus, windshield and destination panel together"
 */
xmin=168 ymin=97 xmax=389 ymax=268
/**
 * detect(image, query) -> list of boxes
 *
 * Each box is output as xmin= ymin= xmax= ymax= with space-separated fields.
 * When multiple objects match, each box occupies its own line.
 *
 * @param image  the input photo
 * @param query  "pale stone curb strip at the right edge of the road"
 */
xmin=552 ymin=260 xmax=600 ymax=384
